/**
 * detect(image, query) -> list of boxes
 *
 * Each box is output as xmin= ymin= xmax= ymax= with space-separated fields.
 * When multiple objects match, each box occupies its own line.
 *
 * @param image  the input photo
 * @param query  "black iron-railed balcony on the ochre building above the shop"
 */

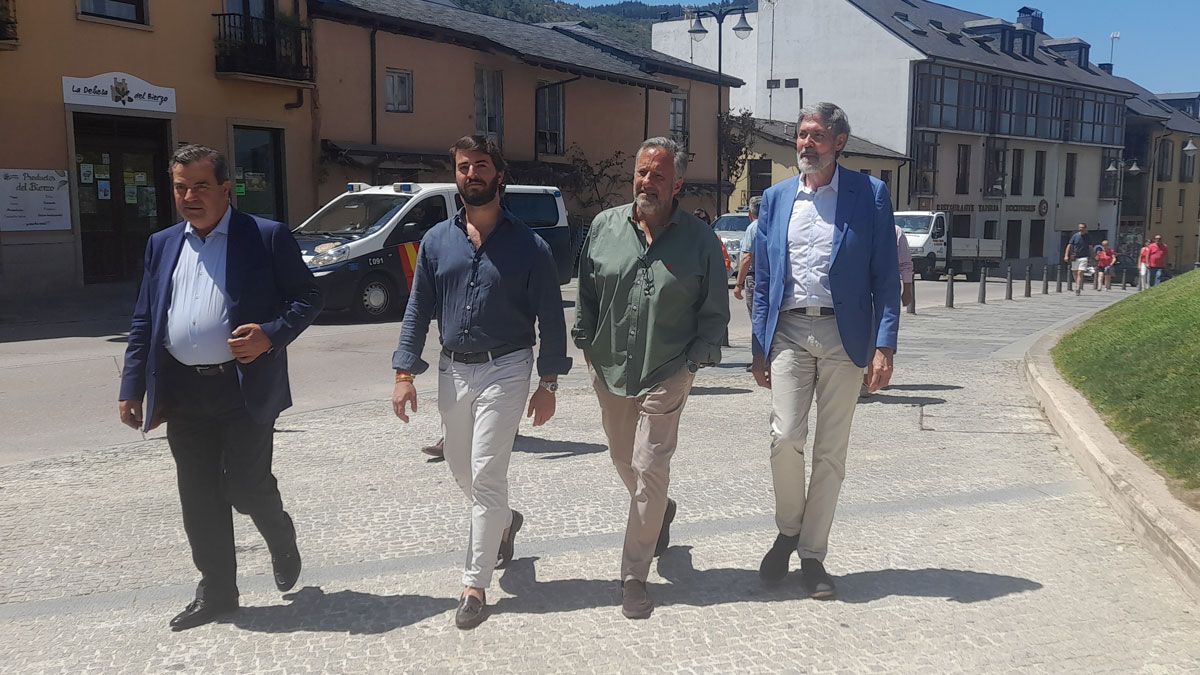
xmin=214 ymin=14 xmax=313 ymax=82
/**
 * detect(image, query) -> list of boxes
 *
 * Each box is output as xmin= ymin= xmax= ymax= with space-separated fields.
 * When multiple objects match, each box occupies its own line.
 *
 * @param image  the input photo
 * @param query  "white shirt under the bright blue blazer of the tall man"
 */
xmin=782 ymin=168 xmax=841 ymax=311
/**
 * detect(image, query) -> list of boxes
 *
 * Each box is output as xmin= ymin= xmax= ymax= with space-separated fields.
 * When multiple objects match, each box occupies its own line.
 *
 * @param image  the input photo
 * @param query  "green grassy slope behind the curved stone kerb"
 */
xmin=1052 ymin=271 xmax=1200 ymax=490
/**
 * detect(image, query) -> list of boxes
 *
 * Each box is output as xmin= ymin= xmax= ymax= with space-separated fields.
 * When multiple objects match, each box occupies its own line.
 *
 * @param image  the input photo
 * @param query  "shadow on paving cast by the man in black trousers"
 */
xmin=221 ymin=586 xmax=458 ymax=635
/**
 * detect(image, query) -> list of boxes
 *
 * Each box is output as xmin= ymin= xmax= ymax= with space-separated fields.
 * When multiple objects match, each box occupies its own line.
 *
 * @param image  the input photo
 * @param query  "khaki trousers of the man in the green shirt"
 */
xmin=589 ymin=368 xmax=695 ymax=583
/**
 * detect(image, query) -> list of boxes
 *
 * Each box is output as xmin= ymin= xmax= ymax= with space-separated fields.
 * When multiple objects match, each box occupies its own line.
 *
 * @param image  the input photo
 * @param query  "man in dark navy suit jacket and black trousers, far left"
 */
xmin=119 ymin=145 xmax=322 ymax=631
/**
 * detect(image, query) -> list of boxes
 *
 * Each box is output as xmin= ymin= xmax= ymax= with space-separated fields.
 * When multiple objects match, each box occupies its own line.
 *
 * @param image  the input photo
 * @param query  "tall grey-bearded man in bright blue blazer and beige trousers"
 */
xmin=751 ymin=103 xmax=900 ymax=599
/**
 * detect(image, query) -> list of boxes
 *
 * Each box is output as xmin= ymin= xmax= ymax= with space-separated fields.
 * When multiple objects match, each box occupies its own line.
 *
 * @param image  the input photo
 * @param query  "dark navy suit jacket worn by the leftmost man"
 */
xmin=119 ymin=210 xmax=324 ymax=430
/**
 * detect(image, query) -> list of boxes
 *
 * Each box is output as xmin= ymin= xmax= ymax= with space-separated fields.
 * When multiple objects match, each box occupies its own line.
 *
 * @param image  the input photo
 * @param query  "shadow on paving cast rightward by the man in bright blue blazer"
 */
xmin=835 ymin=568 xmax=1042 ymax=603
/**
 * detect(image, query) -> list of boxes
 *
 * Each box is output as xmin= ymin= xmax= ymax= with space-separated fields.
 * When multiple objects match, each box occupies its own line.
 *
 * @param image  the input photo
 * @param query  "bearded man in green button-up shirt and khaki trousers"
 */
xmin=571 ymin=138 xmax=730 ymax=619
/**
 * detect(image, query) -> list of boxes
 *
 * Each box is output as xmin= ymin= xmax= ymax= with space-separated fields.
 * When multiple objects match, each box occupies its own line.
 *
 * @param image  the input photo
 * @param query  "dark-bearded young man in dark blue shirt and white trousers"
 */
xmin=391 ymin=136 xmax=571 ymax=628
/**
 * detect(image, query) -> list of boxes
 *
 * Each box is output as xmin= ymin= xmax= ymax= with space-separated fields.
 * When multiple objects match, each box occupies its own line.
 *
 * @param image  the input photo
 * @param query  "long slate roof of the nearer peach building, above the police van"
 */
xmin=311 ymin=0 xmax=676 ymax=91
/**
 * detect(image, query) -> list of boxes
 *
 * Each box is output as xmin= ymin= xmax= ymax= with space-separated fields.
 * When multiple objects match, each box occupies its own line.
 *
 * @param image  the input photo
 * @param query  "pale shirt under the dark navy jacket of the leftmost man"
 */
xmin=167 ymin=208 xmax=233 ymax=365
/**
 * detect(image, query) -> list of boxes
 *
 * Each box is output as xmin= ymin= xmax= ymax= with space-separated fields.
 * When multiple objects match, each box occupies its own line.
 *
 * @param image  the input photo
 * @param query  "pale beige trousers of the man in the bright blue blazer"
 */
xmin=770 ymin=312 xmax=863 ymax=560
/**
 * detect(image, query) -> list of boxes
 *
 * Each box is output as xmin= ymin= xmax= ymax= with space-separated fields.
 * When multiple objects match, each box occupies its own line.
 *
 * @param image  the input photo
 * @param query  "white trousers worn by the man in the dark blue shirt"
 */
xmin=438 ymin=350 xmax=533 ymax=589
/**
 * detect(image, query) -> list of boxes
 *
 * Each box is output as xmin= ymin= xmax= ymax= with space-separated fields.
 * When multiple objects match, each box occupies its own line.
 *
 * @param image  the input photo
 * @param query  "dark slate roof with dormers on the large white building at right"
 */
xmin=847 ymin=0 xmax=1132 ymax=94
